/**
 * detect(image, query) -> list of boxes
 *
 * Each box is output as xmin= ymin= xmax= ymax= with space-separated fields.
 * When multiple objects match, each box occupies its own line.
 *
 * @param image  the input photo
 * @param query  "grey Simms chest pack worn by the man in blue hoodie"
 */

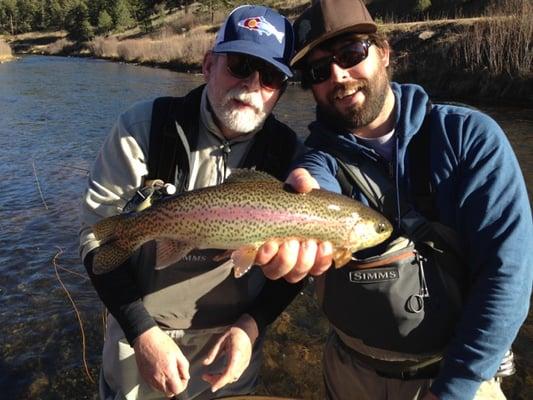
xmin=322 ymin=241 xmax=459 ymax=354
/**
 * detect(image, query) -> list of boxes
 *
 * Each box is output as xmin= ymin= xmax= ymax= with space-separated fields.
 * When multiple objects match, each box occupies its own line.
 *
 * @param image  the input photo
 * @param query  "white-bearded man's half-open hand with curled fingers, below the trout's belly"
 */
xmin=202 ymin=314 xmax=259 ymax=392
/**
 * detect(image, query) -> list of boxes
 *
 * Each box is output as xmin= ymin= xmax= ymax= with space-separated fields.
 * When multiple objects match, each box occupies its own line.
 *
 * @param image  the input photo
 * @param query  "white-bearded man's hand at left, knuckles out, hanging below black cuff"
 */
xmin=133 ymin=327 xmax=190 ymax=397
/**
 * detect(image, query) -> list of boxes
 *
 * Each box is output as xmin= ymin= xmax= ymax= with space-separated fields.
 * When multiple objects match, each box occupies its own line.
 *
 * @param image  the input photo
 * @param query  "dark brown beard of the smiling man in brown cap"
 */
xmin=322 ymin=69 xmax=390 ymax=132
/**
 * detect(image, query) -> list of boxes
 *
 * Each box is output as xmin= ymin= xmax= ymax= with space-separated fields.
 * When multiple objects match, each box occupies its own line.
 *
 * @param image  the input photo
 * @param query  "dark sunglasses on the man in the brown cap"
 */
xmin=303 ymin=40 xmax=372 ymax=85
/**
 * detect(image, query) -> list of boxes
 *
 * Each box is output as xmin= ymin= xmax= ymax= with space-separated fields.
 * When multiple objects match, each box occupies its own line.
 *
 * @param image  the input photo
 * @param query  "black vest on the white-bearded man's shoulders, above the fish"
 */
xmin=124 ymin=86 xmax=298 ymax=211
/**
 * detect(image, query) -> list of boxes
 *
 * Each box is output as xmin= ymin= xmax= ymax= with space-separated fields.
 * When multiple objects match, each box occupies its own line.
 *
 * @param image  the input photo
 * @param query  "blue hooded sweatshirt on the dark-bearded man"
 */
xmin=297 ymin=83 xmax=533 ymax=400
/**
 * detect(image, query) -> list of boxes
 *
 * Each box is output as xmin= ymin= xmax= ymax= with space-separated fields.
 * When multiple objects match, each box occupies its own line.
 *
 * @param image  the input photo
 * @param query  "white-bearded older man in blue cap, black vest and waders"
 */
xmin=80 ymin=6 xmax=300 ymax=399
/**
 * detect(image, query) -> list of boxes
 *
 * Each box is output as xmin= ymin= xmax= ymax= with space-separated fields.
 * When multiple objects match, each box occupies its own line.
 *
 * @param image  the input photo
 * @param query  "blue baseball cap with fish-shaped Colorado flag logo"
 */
xmin=213 ymin=5 xmax=294 ymax=77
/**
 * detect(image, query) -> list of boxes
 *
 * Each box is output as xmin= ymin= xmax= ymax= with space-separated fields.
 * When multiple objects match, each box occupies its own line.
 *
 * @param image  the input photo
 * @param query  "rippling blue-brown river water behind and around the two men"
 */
xmin=0 ymin=56 xmax=533 ymax=399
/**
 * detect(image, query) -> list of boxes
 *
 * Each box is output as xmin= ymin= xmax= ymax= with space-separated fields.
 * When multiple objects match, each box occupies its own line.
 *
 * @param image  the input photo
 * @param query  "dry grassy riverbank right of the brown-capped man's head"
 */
xmin=385 ymin=15 xmax=533 ymax=105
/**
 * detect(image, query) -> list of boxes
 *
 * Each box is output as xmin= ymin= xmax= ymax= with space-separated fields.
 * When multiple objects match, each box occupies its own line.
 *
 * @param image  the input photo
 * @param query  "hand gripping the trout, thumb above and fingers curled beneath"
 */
xmin=255 ymin=168 xmax=333 ymax=283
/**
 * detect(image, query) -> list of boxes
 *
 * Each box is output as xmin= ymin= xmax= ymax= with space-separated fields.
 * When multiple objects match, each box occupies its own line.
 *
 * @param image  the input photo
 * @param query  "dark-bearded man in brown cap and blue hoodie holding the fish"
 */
xmin=254 ymin=0 xmax=533 ymax=400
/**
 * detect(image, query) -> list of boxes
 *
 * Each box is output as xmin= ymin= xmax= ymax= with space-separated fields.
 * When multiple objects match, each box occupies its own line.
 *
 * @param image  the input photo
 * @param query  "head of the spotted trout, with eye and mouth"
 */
xmin=348 ymin=210 xmax=393 ymax=252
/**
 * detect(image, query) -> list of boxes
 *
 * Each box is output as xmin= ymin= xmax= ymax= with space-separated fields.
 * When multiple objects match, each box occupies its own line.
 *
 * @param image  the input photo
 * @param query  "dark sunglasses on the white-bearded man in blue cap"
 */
xmin=222 ymin=53 xmax=289 ymax=90
